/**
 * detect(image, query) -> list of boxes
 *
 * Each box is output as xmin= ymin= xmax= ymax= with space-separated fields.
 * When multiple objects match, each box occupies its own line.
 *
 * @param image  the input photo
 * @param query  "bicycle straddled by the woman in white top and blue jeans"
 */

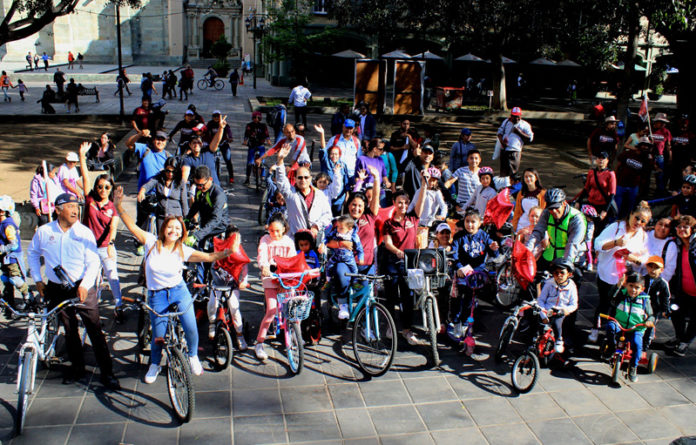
xmin=123 ymin=297 xmax=196 ymax=423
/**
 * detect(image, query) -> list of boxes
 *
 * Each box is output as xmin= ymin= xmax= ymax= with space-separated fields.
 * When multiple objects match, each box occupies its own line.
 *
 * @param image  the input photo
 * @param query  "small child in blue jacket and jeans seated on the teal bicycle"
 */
xmin=324 ymin=215 xmax=365 ymax=320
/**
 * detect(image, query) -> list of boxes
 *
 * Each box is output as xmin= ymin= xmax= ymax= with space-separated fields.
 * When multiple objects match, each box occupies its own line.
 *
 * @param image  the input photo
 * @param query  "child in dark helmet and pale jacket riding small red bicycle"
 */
xmin=537 ymin=258 xmax=578 ymax=354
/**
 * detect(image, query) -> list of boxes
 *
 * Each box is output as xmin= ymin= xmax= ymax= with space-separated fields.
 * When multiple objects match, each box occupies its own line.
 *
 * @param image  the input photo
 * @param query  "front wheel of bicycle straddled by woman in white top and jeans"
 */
xmin=167 ymin=348 xmax=196 ymax=422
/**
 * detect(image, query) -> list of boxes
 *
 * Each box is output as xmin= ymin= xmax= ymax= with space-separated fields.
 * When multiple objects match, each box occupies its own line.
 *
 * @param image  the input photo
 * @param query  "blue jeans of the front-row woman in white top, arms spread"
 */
xmin=148 ymin=280 xmax=198 ymax=365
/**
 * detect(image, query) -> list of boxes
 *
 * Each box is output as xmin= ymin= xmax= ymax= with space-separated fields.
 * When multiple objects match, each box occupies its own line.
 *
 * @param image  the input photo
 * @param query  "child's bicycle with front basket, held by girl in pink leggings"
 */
xmin=271 ymin=269 xmax=319 ymax=374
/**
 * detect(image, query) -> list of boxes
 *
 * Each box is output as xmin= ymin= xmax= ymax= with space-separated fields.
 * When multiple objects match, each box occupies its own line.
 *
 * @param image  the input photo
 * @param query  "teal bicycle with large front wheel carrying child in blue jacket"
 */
xmin=328 ymin=273 xmax=397 ymax=377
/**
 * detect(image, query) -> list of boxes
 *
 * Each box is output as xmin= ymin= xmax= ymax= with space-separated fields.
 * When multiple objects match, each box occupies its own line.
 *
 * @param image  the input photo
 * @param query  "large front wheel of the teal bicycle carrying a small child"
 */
xmin=353 ymin=303 xmax=396 ymax=377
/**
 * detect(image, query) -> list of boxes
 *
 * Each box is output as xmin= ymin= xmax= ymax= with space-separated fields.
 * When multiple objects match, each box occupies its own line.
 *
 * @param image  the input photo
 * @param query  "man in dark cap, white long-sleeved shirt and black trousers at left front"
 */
xmin=27 ymin=193 xmax=120 ymax=390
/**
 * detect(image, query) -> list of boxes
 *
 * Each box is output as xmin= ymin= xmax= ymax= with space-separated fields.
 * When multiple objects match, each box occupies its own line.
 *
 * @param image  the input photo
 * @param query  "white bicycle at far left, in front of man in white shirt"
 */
xmin=0 ymin=298 xmax=81 ymax=434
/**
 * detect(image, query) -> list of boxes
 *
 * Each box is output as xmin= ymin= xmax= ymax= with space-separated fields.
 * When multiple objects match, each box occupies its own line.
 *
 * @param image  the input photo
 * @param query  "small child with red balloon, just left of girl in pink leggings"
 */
xmin=208 ymin=225 xmax=249 ymax=351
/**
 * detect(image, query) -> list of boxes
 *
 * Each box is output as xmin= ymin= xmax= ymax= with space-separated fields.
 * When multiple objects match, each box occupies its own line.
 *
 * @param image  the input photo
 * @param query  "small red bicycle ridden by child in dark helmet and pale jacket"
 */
xmin=512 ymin=301 xmax=560 ymax=393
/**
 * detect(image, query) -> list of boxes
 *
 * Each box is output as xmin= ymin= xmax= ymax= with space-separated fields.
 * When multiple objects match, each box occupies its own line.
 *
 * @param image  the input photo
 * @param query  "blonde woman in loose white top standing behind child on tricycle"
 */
xmin=589 ymin=201 xmax=652 ymax=342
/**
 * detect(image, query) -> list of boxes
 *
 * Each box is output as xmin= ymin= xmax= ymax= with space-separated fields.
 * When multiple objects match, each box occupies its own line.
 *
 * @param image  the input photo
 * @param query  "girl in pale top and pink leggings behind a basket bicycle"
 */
xmin=254 ymin=214 xmax=297 ymax=361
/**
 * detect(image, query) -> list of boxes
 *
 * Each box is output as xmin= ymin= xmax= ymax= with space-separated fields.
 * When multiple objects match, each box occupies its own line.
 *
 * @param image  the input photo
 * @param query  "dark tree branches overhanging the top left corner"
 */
xmin=0 ymin=0 xmax=140 ymax=45
